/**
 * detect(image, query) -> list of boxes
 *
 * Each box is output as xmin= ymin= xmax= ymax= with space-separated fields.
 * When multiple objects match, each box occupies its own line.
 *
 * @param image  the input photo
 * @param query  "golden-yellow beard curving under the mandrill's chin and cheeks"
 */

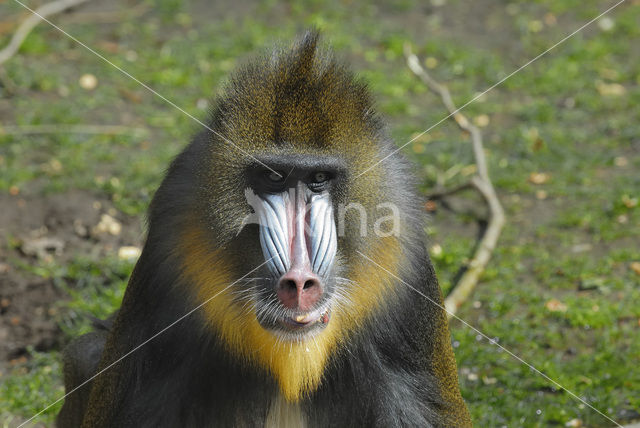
xmin=180 ymin=228 xmax=399 ymax=402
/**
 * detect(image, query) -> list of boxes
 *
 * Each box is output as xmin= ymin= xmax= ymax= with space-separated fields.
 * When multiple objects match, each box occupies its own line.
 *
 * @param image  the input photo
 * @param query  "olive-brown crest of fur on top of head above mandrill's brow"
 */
xmin=213 ymin=31 xmax=379 ymax=157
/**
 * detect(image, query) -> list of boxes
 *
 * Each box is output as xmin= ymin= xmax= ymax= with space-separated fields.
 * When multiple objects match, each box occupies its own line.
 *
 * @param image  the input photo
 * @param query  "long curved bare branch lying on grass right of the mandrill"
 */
xmin=404 ymin=45 xmax=505 ymax=317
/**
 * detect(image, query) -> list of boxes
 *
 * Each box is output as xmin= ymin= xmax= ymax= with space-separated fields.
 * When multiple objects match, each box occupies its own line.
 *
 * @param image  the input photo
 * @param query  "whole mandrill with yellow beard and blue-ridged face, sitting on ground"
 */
xmin=58 ymin=32 xmax=471 ymax=428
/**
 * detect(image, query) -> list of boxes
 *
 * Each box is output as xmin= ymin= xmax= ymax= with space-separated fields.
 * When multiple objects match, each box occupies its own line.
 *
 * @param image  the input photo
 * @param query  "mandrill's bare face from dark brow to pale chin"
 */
xmin=246 ymin=155 xmax=346 ymax=340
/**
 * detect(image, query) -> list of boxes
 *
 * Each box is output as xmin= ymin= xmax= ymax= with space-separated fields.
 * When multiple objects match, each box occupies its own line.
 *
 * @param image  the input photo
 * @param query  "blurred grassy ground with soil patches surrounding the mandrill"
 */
xmin=0 ymin=0 xmax=640 ymax=427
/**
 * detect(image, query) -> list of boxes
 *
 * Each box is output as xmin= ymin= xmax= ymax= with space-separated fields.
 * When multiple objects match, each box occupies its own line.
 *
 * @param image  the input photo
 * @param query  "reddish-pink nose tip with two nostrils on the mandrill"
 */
xmin=276 ymin=269 xmax=322 ymax=312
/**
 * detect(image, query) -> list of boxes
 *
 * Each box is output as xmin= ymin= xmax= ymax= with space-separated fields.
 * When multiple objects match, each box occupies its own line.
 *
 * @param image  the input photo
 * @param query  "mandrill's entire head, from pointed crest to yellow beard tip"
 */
xmin=150 ymin=32 xmax=420 ymax=401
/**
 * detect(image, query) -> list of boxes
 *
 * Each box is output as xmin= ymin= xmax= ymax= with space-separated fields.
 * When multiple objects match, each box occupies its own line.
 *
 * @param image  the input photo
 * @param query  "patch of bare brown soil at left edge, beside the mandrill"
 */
xmin=0 ymin=190 xmax=142 ymax=368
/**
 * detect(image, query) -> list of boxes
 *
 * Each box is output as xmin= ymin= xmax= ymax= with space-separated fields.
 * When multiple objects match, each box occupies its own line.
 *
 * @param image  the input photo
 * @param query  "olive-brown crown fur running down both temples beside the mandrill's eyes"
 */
xmin=201 ymin=31 xmax=385 ymax=242
